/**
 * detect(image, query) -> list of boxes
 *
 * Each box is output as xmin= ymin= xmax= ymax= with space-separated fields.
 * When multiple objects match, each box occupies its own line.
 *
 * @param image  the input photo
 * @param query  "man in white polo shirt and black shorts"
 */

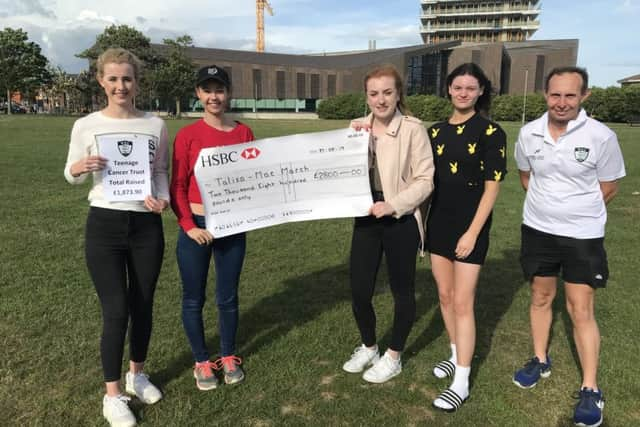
xmin=513 ymin=67 xmax=625 ymax=427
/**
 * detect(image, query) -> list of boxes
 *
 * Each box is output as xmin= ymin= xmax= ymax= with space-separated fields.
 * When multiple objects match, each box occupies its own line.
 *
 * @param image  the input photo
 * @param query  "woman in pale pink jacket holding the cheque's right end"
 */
xmin=343 ymin=65 xmax=434 ymax=383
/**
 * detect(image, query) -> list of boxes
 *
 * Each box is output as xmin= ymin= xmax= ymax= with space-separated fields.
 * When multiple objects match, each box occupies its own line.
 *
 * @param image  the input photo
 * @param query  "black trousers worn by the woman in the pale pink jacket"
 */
xmin=350 ymin=215 xmax=420 ymax=351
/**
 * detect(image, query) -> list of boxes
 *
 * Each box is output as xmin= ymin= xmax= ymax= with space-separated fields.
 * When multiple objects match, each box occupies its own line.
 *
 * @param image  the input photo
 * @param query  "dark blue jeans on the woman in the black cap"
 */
xmin=176 ymin=215 xmax=246 ymax=362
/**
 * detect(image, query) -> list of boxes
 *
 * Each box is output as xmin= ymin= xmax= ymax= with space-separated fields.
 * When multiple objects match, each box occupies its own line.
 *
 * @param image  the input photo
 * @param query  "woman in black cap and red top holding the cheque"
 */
xmin=171 ymin=65 xmax=254 ymax=390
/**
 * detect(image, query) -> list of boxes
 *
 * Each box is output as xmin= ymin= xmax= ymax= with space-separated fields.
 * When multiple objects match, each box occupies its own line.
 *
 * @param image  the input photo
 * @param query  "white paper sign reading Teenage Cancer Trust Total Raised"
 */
xmin=96 ymin=133 xmax=152 ymax=202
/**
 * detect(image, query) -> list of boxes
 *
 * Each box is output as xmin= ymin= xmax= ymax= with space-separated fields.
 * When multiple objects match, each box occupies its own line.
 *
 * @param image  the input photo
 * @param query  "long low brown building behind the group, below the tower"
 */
xmin=161 ymin=36 xmax=578 ymax=111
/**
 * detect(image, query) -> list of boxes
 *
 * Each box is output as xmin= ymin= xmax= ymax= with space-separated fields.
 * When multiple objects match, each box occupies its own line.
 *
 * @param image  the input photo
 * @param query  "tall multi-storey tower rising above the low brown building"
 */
xmin=420 ymin=0 xmax=540 ymax=44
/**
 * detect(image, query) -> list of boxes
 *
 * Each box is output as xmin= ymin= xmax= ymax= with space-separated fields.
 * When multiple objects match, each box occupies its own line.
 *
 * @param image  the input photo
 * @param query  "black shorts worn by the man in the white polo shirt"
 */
xmin=520 ymin=224 xmax=609 ymax=288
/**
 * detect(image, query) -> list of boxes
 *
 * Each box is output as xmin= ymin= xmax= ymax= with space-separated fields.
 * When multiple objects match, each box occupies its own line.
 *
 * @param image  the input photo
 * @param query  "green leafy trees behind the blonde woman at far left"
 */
xmin=0 ymin=25 xmax=195 ymax=114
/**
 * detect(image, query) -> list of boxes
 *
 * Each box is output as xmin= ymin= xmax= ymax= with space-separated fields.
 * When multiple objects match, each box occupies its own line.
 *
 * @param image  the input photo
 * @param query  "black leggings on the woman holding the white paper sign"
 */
xmin=85 ymin=207 xmax=164 ymax=382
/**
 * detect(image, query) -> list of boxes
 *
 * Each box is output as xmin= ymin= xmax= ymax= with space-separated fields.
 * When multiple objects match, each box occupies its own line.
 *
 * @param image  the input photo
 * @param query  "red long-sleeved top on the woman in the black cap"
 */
xmin=170 ymin=120 xmax=255 ymax=232
